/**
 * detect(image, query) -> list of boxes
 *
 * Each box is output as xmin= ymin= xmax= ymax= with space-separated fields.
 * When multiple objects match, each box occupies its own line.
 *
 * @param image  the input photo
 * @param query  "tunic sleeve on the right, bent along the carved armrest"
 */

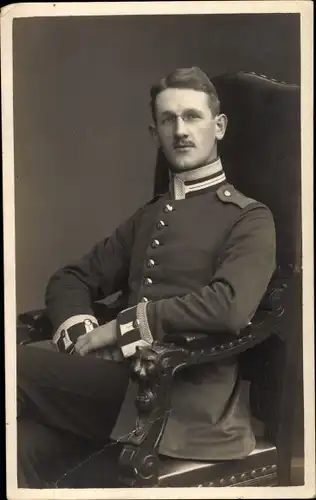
xmin=119 ymin=204 xmax=276 ymax=352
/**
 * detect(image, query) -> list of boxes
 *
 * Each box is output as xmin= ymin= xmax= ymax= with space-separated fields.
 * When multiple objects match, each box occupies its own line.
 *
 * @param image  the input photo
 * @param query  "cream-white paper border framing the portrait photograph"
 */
xmin=1 ymin=0 xmax=315 ymax=500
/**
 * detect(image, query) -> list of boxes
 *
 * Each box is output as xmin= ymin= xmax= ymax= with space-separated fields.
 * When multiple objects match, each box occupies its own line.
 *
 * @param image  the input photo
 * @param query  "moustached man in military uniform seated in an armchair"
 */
xmin=17 ymin=67 xmax=275 ymax=487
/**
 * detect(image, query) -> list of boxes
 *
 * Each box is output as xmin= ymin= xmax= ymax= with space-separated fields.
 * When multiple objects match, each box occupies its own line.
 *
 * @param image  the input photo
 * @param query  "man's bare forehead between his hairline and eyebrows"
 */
xmin=156 ymin=88 xmax=209 ymax=113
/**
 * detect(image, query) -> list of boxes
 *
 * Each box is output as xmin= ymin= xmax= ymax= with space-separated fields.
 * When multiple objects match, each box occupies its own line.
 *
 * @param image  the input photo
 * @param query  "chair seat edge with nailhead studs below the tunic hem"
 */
xmin=159 ymin=438 xmax=277 ymax=487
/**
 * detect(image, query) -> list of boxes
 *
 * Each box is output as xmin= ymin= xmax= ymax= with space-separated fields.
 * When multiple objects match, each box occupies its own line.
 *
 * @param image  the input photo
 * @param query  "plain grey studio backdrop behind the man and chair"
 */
xmin=13 ymin=14 xmax=300 ymax=313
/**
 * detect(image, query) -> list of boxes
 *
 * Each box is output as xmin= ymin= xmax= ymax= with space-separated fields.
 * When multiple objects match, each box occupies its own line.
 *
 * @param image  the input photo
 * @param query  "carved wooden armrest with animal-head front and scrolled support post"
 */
xmin=119 ymin=300 xmax=283 ymax=487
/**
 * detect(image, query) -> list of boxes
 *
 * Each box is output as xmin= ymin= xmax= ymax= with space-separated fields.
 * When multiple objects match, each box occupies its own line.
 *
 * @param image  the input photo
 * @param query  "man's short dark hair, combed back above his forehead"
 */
xmin=150 ymin=66 xmax=220 ymax=121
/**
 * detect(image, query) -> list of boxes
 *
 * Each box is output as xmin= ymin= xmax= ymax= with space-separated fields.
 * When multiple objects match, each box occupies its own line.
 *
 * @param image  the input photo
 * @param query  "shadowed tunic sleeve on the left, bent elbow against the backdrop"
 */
xmin=45 ymin=205 xmax=142 ymax=333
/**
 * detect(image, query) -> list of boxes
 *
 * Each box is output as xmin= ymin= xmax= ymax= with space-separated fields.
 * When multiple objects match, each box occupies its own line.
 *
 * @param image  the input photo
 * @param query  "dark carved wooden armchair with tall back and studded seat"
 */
xmin=18 ymin=72 xmax=302 ymax=487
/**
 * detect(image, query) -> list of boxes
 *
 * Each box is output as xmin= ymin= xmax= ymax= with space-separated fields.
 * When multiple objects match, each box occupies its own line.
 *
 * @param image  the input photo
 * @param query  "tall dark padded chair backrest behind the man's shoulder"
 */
xmin=154 ymin=72 xmax=301 ymax=437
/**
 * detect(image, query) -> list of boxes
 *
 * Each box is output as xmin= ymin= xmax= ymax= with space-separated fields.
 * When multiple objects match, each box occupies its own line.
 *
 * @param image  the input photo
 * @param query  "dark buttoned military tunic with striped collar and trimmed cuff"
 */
xmin=46 ymin=160 xmax=275 ymax=460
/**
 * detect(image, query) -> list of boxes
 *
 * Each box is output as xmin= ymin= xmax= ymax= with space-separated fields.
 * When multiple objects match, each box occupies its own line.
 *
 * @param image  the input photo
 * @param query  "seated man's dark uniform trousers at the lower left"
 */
xmin=17 ymin=341 xmax=130 ymax=488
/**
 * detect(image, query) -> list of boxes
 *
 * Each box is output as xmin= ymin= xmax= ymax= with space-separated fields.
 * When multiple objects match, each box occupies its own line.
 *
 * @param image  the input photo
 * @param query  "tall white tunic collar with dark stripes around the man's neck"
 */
xmin=169 ymin=157 xmax=226 ymax=200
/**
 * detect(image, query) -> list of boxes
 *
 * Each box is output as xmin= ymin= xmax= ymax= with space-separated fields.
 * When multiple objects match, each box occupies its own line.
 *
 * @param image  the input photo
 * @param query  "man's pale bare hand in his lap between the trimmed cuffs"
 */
xmin=75 ymin=320 xmax=117 ymax=356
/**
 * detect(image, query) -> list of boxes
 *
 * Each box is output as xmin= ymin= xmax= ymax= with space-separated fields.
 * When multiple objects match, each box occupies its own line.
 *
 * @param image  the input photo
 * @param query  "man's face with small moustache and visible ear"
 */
xmin=154 ymin=88 xmax=226 ymax=172
